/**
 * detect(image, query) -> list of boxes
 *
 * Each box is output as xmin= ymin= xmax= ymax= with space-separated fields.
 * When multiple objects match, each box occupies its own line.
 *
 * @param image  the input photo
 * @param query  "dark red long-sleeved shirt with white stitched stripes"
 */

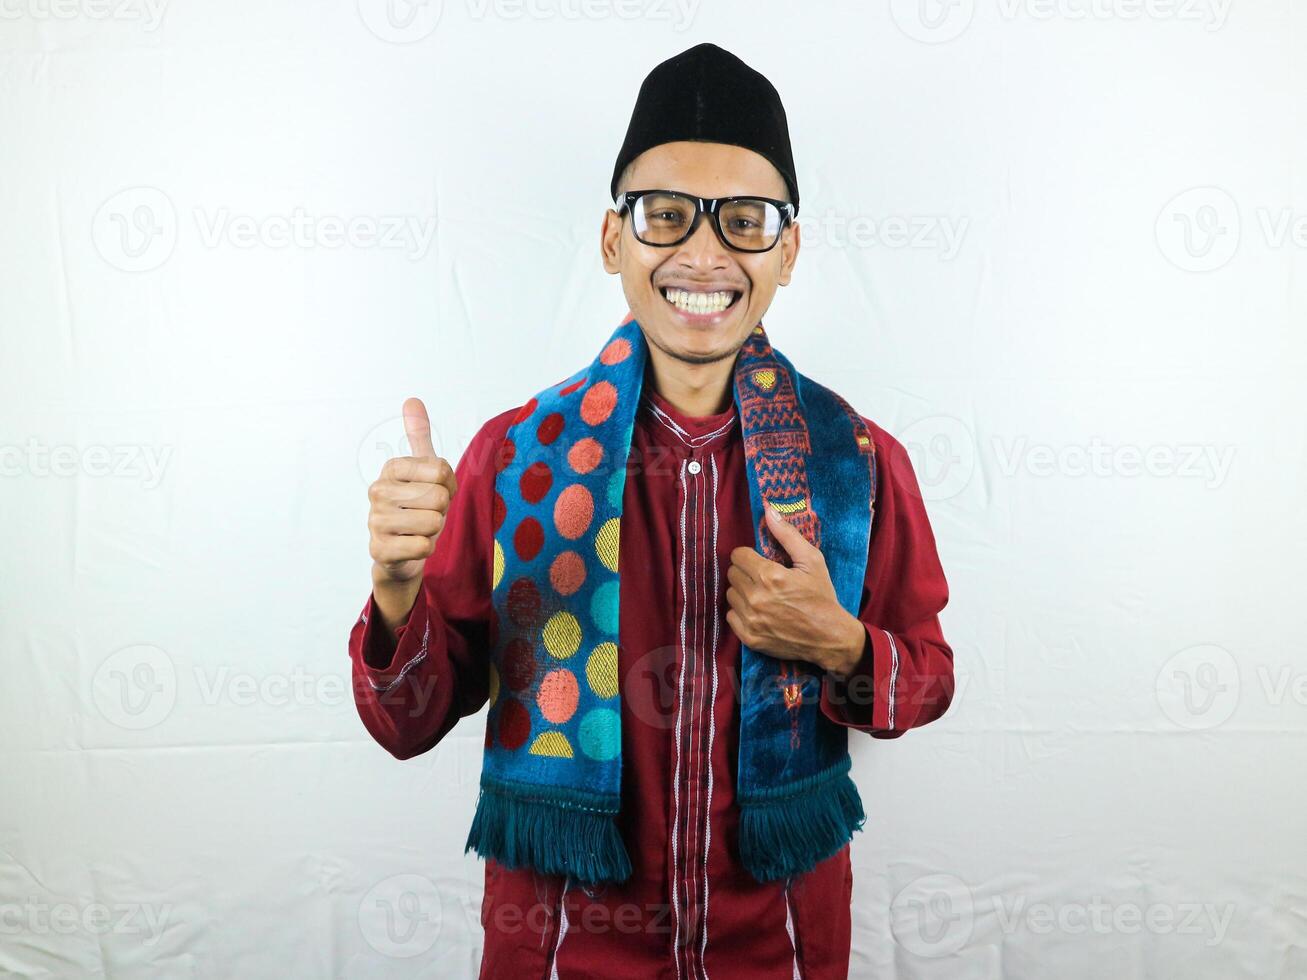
xmin=349 ymin=385 xmax=954 ymax=980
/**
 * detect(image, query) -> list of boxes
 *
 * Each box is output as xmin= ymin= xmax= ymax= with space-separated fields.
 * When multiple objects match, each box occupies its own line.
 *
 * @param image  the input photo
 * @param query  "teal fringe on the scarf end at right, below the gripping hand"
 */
xmin=740 ymin=759 xmax=867 ymax=882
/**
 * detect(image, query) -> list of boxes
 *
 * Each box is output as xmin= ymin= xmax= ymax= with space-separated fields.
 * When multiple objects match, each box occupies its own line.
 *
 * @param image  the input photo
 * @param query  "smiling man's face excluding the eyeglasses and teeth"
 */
xmin=601 ymin=141 xmax=799 ymax=363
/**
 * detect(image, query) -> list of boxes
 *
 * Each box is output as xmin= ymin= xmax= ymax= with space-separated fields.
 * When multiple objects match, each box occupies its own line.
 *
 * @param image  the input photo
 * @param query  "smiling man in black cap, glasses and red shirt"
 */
xmin=349 ymin=44 xmax=953 ymax=980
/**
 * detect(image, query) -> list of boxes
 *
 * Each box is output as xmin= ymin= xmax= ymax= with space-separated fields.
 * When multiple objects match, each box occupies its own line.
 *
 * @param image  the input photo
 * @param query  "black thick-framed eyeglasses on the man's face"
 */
xmin=613 ymin=191 xmax=795 ymax=252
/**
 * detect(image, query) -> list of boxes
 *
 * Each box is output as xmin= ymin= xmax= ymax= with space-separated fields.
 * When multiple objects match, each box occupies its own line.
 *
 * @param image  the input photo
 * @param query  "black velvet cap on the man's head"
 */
xmin=609 ymin=42 xmax=799 ymax=214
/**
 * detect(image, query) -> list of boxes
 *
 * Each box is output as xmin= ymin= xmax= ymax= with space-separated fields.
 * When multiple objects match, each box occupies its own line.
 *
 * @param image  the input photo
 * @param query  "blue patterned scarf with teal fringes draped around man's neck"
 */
xmin=464 ymin=312 xmax=876 ymax=883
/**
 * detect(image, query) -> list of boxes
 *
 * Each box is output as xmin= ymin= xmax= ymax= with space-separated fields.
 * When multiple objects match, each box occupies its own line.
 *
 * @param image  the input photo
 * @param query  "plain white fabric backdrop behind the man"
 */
xmin=0 ymin=0 xmax=1307 ymax=980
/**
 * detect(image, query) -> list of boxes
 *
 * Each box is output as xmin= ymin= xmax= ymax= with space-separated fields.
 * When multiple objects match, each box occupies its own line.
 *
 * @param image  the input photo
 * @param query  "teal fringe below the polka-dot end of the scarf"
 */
xmin=463 ymin=783 xmax=631 ymax=885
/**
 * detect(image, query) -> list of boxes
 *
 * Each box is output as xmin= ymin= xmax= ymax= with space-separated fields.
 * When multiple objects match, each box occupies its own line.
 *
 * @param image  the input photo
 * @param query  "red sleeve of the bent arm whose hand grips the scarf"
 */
xmin=821 ymin=419 xmax=954 ymax=738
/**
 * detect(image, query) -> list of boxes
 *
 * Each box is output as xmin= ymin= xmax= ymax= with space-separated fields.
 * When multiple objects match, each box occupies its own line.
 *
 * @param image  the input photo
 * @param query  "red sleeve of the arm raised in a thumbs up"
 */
xmin=349 ymin=409 xmax=516 ymax=759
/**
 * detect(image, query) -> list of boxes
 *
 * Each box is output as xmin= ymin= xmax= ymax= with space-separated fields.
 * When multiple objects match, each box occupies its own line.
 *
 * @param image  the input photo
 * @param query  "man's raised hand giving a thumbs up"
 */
xmin=367 ymin=399 xmax=457 ymax=588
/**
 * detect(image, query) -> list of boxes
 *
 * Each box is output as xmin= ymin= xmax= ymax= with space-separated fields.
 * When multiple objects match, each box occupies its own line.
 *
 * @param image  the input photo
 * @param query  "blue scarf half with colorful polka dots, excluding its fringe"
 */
xmin=486 ymin=319 xmax=647 ymax=794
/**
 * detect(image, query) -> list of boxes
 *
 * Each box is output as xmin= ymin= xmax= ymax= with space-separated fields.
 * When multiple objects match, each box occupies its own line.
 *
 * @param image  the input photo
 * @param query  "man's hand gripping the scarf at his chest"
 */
xmin=727 ymin=506 xmax=867 ymax=677
